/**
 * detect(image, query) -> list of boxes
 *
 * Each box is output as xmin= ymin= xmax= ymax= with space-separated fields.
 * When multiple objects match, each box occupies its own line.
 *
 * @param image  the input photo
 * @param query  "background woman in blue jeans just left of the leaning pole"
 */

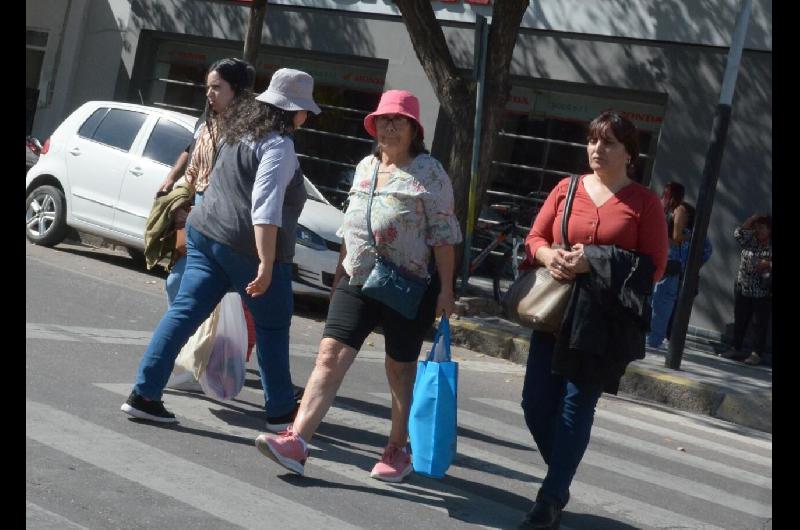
xmin=647 ymin=182 xmax=711 ymax=348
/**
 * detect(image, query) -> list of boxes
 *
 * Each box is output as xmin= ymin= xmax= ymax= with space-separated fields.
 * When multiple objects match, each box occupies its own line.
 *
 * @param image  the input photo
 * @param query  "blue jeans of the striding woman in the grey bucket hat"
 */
xmin=133 ymin=221 xmax=295 ymax=416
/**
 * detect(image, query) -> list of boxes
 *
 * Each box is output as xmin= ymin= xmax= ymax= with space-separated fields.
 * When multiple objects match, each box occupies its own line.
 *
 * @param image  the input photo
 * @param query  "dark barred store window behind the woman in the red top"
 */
xmin=481 ymin=86 xmax=665 ymax=226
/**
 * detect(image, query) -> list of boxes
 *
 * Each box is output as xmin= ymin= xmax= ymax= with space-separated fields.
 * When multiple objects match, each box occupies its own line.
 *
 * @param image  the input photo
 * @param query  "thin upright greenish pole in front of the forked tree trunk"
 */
xmin=459 ymin=15 xmax=489 ymax=296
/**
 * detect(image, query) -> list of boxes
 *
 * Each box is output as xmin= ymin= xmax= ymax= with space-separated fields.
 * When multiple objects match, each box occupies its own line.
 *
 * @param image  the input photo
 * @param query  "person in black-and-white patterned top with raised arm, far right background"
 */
xmin=722 ymin=214 xmax=772 ymax=366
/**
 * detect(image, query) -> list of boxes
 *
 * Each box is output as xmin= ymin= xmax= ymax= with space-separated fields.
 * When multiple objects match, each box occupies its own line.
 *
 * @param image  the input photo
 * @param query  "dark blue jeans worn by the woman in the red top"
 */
xmin=522 ymin=331 xmax=603 ymax=507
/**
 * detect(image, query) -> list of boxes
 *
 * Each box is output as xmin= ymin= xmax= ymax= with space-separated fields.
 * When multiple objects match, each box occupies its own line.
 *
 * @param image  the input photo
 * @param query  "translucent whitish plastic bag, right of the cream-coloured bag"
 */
xmin=199 ymin=293 xmax=247 ymax=399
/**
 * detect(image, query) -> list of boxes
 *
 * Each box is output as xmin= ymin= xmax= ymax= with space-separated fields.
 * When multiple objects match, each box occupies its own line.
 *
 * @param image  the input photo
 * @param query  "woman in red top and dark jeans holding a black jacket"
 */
xmin=519 ymin=112 xmax=667 ymax=529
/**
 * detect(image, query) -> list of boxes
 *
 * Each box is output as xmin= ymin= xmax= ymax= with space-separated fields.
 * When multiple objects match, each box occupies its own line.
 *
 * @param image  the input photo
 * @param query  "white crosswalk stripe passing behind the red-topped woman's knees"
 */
xmin=472 ymin=398 xmax=772 ymax=490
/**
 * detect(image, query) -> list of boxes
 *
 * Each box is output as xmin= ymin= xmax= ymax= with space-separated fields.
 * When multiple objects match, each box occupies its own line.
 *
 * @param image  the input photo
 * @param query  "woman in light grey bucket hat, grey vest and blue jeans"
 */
xmin=121 ymin=68 xmax=320 ymax=431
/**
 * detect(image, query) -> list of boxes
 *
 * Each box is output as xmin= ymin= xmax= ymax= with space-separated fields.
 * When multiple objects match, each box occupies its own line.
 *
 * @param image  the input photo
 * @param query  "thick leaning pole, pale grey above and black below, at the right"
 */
xmin=664 ymin=0 xmax=752 ymax=370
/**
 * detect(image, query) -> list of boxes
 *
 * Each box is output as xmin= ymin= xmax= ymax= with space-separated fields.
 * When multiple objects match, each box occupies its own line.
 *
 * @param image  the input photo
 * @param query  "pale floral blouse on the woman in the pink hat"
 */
xmin=337 ymin=154 xmax=461 ymax=285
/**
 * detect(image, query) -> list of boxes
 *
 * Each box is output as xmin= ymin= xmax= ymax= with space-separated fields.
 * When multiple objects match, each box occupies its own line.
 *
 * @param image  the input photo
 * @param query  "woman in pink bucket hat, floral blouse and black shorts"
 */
xmin=256 ymin=90 xmax=461 ymax=482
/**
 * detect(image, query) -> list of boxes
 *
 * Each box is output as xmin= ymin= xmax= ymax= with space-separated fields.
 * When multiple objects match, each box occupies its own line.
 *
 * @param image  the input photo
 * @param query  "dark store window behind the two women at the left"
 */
xmin=131 ymin=32 xmax=388 ymax=207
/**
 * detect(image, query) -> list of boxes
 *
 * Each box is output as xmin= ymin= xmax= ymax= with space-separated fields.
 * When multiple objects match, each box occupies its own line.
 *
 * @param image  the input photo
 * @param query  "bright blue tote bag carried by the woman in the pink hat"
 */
xmin=408 ymin=316 xmax=458 ymax=478
